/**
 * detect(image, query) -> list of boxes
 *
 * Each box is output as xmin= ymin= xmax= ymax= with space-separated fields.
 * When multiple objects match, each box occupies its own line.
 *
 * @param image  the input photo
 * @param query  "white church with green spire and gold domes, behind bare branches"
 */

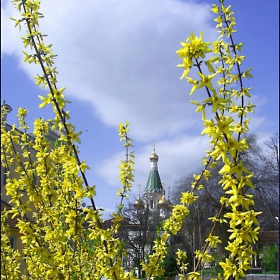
xmin=115 ymin=149 xmax=173 ymax=278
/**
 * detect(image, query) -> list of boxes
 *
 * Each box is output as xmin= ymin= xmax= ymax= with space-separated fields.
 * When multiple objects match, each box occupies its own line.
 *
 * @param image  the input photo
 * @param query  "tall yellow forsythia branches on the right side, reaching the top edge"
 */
xmin=143 ymin=1 xmax=260 ymax=279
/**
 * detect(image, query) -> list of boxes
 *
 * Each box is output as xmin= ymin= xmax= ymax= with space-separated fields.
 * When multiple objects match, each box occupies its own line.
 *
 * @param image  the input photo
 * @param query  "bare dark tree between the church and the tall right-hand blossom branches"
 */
xmin=172 ymin=162 xmax=229 ymax=267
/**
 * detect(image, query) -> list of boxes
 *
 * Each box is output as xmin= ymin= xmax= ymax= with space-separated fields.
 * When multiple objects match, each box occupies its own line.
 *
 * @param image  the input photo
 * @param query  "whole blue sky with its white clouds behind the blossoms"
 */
xmin=1 ymin=0 xmax=279 ymax=218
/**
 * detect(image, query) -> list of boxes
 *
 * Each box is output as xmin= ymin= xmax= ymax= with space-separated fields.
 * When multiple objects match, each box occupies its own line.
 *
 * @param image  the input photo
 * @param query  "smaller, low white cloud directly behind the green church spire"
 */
xmin=95 ymin=132 xmax=209 ymax=194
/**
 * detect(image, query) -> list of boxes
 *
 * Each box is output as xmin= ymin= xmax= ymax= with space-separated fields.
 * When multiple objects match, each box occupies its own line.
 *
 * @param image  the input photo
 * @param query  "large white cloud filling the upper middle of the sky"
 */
xmin=2 ymin=0 xmax=217 ymax=142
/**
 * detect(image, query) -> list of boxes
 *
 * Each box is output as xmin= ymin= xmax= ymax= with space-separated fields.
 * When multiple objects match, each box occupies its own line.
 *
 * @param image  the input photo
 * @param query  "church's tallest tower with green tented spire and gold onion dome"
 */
xmin=144 ymin=149 xmax=164 ymax=210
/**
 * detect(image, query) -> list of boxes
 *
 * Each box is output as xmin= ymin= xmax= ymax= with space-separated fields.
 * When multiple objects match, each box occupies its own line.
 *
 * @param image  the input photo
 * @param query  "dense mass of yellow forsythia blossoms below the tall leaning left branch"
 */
xmin=1 ymin=105 xmax=133 ymax=279
